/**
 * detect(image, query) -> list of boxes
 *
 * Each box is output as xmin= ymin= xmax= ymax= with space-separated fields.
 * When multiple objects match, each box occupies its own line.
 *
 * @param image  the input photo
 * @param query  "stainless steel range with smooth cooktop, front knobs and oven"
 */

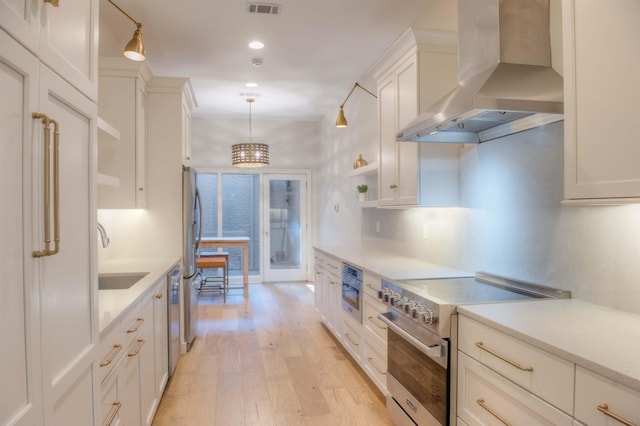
xmin=378 ymin=273 xmax=571 ymax=426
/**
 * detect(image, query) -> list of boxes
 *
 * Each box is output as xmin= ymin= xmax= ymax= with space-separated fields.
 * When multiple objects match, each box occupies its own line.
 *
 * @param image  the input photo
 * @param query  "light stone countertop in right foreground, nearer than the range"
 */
xmin=458 ymin=299 xmax=640 ymax=392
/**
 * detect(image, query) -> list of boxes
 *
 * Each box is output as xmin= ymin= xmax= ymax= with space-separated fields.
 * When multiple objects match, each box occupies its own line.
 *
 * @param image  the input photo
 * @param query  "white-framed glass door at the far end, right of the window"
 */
xmin=262 ymin=174 xmax=307 ymax=282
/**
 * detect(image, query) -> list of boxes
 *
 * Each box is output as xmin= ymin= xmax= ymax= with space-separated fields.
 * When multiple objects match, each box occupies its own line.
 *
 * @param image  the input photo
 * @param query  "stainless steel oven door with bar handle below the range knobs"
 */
xmin=378 ymin=311 xmax=449 ymax=426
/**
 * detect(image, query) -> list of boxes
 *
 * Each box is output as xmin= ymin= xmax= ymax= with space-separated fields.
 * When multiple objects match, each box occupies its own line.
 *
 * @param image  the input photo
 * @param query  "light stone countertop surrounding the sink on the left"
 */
xmin=98 ymin=257 xmax=181 ymax=333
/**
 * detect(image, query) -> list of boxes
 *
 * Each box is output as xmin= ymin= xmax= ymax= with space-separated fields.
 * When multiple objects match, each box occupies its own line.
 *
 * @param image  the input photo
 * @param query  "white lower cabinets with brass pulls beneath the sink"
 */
xmin=99 ymin=277 xmax=169 ymax=425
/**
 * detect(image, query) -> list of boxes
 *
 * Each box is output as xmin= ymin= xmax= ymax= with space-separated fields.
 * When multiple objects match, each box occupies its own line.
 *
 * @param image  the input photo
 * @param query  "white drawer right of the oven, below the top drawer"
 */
xmin=458 ymin=353 xmax=573 ymax=426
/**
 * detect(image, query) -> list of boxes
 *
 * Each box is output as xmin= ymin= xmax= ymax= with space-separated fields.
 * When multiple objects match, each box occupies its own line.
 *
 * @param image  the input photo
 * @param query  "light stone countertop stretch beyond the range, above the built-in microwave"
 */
xmin=315 ymin=246 xmax=474 ymax=280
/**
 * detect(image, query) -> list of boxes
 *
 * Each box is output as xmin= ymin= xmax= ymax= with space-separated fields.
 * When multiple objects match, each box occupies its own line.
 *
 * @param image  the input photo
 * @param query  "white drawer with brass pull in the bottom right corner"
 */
xmin=575 ymin=367 xmax=640 ymax=426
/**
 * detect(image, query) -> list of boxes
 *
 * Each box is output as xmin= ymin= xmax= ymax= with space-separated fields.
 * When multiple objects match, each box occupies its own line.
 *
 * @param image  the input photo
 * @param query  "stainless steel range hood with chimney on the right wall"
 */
xmin=396 ymin=0 xmax=563 ymax=143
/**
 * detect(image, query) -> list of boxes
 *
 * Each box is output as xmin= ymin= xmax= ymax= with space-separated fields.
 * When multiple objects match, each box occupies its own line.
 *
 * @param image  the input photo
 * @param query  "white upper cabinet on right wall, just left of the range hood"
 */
xmin=374 ymin=29 xmax=459 ymax=207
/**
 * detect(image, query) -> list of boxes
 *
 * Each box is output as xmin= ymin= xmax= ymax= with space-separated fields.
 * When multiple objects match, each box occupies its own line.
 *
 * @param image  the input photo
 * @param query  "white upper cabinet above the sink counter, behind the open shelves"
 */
xmin=98 ymin=58 xmax=151 ymax=209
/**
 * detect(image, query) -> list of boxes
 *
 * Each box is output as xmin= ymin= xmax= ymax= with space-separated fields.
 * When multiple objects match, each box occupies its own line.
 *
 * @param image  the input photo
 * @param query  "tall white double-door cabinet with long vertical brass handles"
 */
xmin=0 ymin=31 xmax=97 ymax=425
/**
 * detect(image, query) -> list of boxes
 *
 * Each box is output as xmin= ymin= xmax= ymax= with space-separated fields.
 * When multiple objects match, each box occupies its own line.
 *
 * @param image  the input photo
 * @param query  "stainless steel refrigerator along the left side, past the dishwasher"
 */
xmin=182 ymin=167 xmax=203 ymax=351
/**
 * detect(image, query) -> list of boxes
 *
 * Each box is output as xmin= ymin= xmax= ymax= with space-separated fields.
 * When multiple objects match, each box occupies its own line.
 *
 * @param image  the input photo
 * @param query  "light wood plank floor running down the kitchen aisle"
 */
xmin=153 ymin=283 xmax=393 ymax=426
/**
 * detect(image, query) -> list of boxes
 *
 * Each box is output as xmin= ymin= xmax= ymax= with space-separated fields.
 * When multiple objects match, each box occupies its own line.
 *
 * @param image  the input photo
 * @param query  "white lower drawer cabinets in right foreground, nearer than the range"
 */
xmin=456 ymin=315 xmax=640 ymax=426
